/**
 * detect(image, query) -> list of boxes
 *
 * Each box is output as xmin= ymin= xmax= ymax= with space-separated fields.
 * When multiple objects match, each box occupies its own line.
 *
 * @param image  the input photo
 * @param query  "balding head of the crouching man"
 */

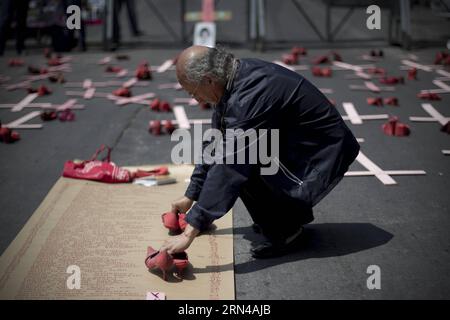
xmin=176 ymin=46 xmax=234 ymax=104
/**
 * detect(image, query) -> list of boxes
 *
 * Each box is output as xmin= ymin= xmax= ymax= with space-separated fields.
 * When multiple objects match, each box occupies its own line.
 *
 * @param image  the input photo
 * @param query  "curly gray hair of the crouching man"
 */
xmin=185 ymin=48 xmax=234 ymax=85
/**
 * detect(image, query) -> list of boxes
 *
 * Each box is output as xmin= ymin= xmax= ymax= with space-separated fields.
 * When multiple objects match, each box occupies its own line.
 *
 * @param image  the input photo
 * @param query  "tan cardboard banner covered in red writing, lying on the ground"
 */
xmin=0 ymin=165 xmax=234 ymax=300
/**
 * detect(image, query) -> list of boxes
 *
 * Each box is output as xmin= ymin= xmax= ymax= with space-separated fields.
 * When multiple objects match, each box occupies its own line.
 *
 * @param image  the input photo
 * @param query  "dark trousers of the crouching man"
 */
xmin=239 ymin=169 xmax=314 ymax=242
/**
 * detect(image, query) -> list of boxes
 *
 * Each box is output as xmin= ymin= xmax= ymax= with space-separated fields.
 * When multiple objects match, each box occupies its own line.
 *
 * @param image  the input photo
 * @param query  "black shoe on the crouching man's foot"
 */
xmin=250 ymin=227 xmax=304 ymax=259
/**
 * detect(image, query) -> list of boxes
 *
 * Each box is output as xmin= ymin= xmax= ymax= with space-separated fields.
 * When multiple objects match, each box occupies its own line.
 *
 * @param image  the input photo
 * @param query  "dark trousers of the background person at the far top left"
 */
xmin=0 ymin=0 xmax=29 ymax=55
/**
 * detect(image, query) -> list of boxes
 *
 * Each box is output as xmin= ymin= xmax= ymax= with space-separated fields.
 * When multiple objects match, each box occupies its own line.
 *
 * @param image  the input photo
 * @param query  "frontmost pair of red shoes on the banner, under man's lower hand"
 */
xmin=145 ymin=246 xmax=189 ymax=280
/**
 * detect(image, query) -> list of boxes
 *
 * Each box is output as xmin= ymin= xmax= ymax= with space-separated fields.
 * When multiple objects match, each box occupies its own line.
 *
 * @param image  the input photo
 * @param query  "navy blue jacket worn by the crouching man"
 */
xmin=185 ymin=59 xmax=359 ymax=230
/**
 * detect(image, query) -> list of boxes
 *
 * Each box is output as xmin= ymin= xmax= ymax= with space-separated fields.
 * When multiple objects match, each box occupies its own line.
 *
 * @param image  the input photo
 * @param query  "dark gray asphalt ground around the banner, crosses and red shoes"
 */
xmin=0 ymin=48 xmax=450 ymax=299
